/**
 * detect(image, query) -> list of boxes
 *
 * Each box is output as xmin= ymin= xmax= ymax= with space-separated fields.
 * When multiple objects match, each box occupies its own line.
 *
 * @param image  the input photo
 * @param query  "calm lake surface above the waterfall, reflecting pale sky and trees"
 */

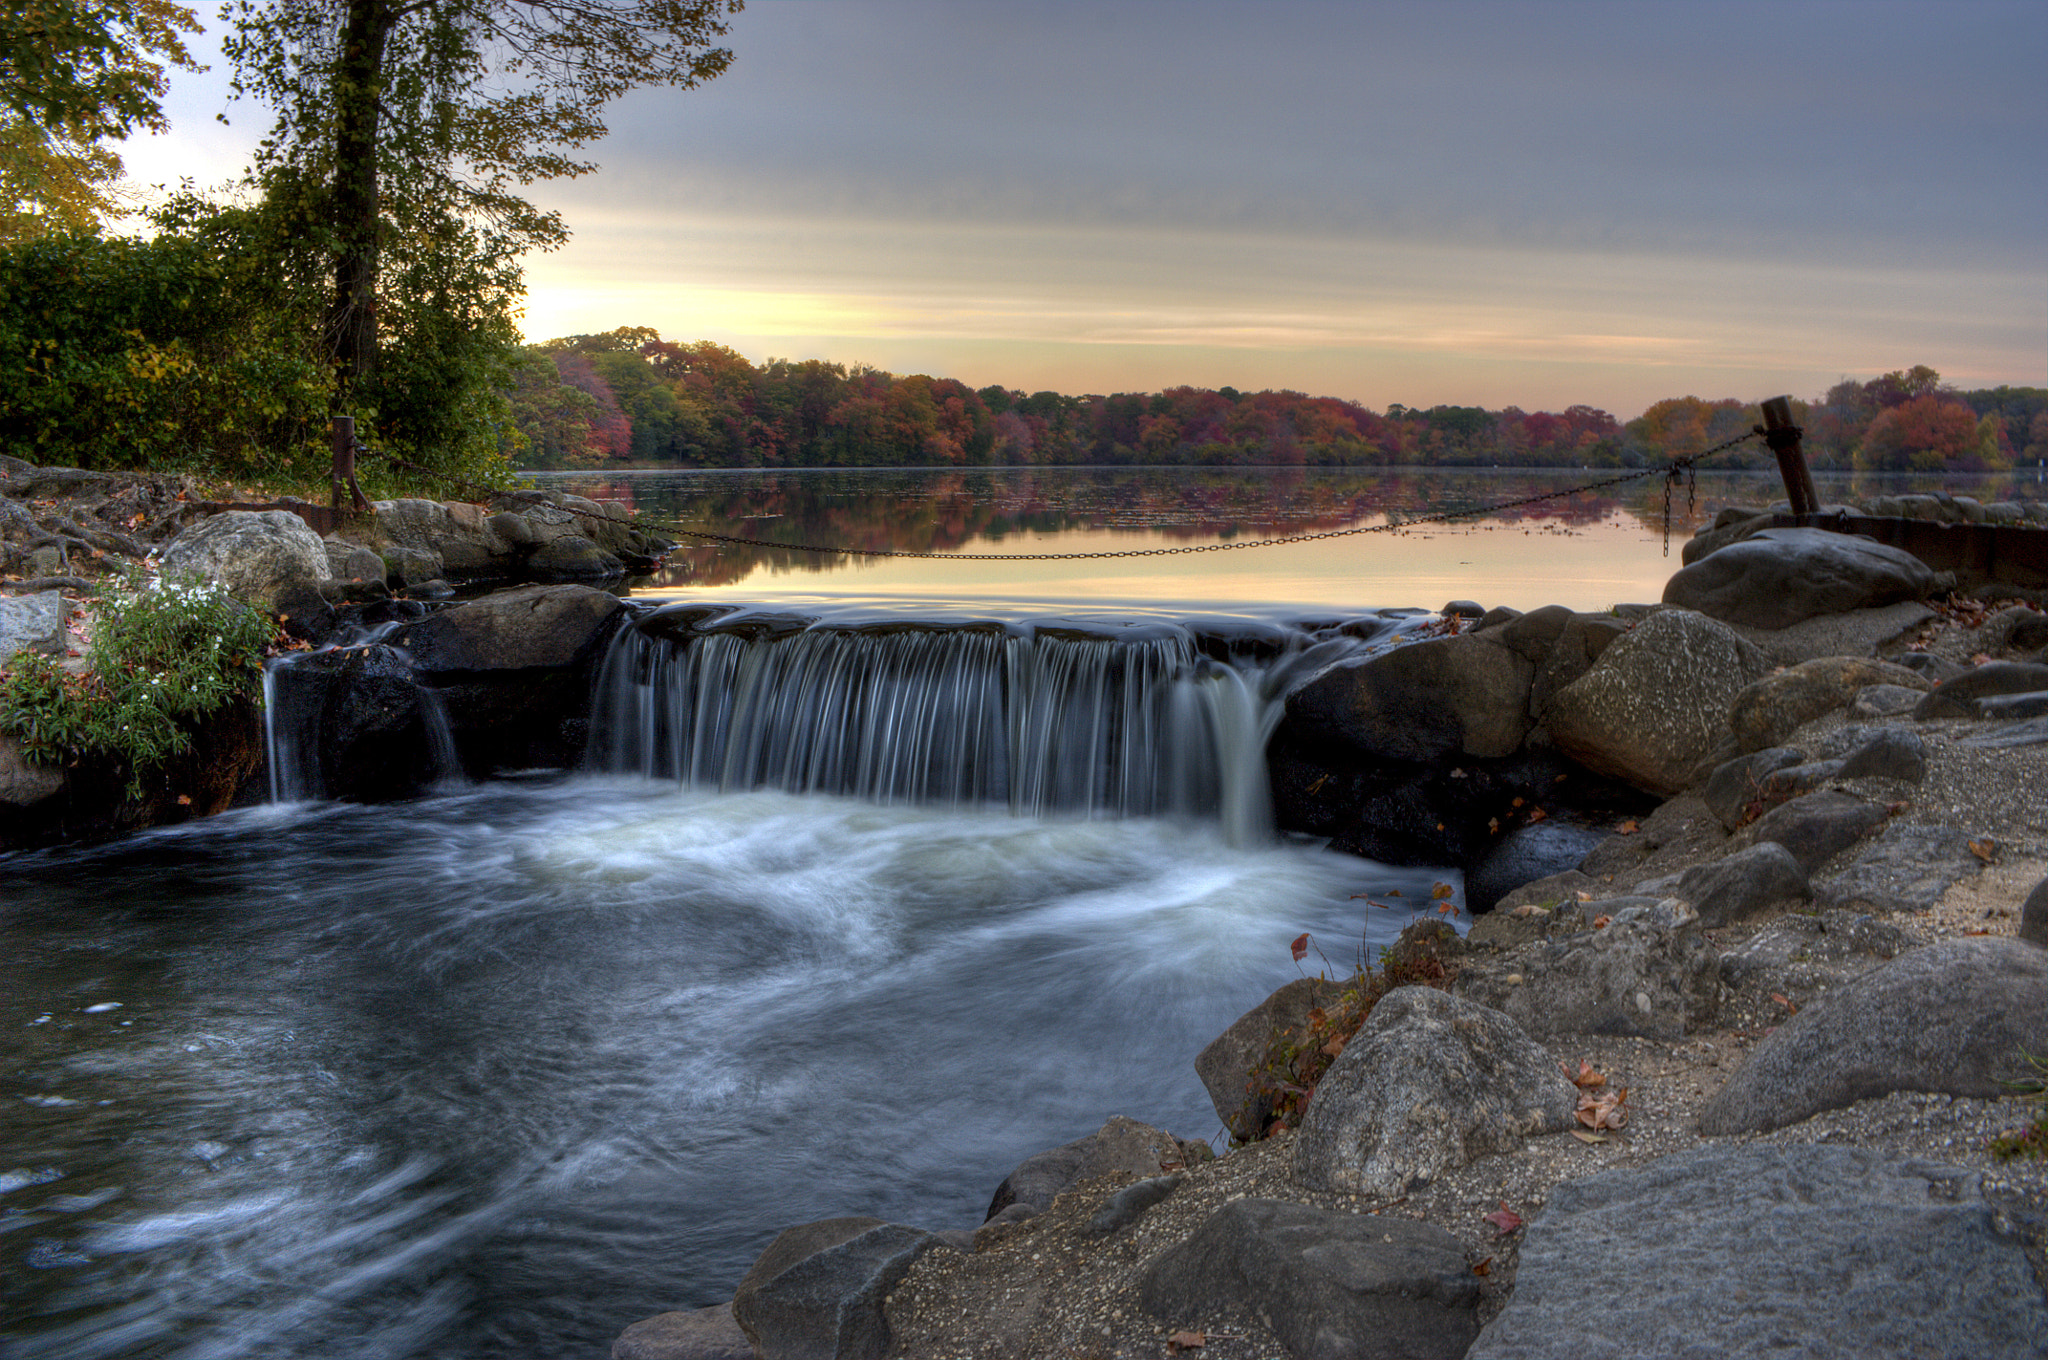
xmin=547 ymin=467 xmax=2032 ymax=612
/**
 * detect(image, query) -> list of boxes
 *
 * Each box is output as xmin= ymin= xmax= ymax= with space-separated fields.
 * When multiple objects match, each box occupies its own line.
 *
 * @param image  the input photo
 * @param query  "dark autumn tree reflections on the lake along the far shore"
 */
xmin=540 ymin=467 xmax=2009 ymax=586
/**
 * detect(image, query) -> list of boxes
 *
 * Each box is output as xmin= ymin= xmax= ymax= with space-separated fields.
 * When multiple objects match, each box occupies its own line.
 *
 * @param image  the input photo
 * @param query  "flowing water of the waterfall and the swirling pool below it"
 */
xmin=0 ymin=464 xmax=2023 ymax=1360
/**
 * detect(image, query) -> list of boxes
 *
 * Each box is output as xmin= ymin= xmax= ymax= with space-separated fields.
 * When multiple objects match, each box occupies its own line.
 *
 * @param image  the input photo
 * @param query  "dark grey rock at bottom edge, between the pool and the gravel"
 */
xmin=733 ymin=1219 xmax=940 ymax=1360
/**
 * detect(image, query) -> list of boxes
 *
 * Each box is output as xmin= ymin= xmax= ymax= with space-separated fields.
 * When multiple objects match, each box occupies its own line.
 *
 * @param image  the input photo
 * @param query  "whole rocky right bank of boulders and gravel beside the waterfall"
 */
xmin=612 ymin=516 xmax=2048 ymax=1360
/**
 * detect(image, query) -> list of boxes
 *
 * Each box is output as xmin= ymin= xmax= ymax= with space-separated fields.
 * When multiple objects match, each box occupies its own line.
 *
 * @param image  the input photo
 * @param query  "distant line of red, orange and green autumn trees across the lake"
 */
xmin=510 ymin=326 xmax=2048 ymax=471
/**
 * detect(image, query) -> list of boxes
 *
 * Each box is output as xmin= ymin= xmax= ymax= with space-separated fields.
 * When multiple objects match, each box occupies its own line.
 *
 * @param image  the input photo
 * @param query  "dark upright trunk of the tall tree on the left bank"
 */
xmin=328 ymin=0 xmax=395 ymax=403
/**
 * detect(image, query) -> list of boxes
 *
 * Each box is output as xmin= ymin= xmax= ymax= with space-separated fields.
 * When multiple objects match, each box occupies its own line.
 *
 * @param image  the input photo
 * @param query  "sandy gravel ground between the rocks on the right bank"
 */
xmin=889 ymin=606 xmax=2048 ymax=1360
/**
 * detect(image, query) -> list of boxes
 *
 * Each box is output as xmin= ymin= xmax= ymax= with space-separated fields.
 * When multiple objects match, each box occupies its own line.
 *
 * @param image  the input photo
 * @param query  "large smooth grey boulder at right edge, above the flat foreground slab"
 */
xmin=1700 ymin=938 xmax=2048 ymax=1135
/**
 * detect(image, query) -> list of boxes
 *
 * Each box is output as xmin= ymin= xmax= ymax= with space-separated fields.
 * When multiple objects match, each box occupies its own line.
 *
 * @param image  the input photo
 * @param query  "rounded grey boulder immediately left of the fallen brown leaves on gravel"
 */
xmin=1292 ymin=987 xmax=1579 ymax=1198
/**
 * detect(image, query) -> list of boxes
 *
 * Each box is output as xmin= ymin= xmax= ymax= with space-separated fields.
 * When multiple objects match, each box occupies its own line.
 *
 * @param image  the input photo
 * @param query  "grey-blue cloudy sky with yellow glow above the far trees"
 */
xmin=123 ymin=0 xmax=2048 ymax=420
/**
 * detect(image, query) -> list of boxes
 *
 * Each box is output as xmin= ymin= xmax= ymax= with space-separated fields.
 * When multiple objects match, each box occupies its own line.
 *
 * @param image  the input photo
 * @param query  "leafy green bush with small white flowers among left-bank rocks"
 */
xmin=0 ymin=582 xmax=276 ymax=799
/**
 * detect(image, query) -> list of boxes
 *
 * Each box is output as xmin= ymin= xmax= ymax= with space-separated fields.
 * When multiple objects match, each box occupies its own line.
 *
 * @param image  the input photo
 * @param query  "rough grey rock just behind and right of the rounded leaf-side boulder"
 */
xmin=1449 ymin=899 xmax=1720 ymax=1036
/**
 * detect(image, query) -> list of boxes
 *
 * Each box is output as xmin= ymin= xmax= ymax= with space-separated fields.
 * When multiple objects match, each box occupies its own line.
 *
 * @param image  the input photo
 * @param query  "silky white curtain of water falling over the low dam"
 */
xmin=590 ymin=606 xmax=1392 ymax=844
